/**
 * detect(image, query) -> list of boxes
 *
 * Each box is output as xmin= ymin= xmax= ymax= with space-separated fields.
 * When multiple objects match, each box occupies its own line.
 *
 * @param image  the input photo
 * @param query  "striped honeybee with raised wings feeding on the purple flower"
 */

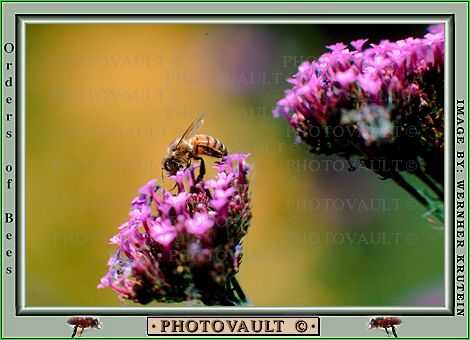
xmin=162 ymin=116 xmax=227 ymax=182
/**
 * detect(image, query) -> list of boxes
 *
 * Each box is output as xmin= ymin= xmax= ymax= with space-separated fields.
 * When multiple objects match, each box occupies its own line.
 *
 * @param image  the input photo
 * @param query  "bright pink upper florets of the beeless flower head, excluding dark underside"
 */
xmin=273 ymin=25 xmax=444 ymax=128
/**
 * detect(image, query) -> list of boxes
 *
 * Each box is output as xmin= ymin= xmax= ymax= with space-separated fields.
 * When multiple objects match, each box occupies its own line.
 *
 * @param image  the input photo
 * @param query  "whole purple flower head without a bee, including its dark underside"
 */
xmin=273 ymin=25 xmax=444 ymax=185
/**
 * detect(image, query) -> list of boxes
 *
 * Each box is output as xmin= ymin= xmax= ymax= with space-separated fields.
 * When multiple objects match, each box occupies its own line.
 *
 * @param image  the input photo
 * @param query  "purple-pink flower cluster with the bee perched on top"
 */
xmin=98 ymin=154 xmax=251 ymax=305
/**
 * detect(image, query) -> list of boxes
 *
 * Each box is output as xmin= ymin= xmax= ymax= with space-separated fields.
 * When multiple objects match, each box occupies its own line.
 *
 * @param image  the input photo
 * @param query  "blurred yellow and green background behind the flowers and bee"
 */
xmin=26 ymin=24 xmax=444 ymax=306
